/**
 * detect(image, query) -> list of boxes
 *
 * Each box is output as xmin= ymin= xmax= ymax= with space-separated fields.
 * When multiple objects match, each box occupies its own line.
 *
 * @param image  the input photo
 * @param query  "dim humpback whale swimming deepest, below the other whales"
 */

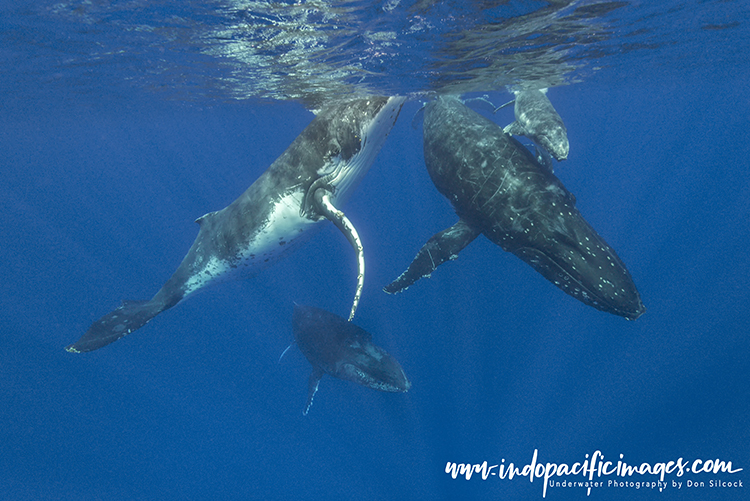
xmin=292 ymin=305 xmax=411 ymax=416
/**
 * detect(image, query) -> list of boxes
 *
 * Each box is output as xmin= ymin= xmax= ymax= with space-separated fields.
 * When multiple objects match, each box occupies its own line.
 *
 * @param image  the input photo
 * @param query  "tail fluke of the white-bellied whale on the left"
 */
xmin=65 ymin=300 xmax=165 ymax=353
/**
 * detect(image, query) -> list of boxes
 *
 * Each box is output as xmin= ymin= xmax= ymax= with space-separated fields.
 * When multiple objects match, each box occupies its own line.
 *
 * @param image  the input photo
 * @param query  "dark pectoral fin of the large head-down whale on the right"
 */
xmin=383 ymin=219 xmax=481 ymax=294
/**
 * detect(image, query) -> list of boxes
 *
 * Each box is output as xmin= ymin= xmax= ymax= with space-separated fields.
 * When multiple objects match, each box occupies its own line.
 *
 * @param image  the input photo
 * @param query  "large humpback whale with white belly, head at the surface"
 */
xmin=66 ymin=97 xmax=405 ymax=353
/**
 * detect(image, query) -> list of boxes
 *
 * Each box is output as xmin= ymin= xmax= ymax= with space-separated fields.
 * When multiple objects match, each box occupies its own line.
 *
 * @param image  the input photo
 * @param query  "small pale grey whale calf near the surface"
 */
xmin=506 ymin=89 xmax=570 ymax=160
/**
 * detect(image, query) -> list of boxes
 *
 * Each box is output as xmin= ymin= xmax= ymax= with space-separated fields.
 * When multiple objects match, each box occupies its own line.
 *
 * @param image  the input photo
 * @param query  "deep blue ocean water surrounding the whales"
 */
xmin=0 ymin=1 xmax=750 ymax=500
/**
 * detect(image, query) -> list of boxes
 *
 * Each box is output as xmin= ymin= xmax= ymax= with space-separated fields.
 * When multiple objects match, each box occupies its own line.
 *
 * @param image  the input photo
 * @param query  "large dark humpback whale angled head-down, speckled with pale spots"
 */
xmin=384 ymin=97 xmax=645 ymax=320
